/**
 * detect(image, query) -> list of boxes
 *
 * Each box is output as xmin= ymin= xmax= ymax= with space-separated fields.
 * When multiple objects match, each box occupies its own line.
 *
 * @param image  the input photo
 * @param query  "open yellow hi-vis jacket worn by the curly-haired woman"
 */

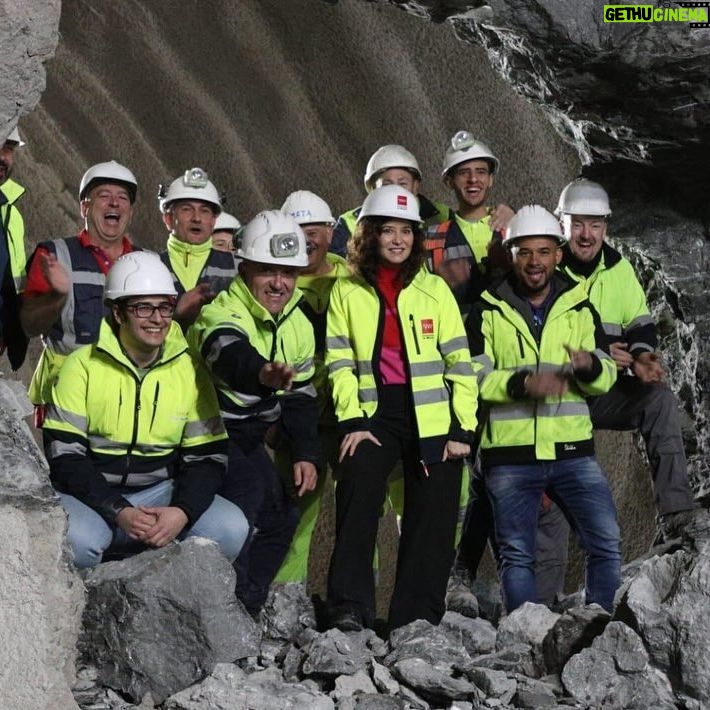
xmin=326 ymin=269 xmax=478 ymax=462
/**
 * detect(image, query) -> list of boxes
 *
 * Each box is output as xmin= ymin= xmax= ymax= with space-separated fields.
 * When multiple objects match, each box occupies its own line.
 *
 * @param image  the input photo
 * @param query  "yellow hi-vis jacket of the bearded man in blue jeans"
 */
xmin=466 ymin=273 xmax=616 ymax=465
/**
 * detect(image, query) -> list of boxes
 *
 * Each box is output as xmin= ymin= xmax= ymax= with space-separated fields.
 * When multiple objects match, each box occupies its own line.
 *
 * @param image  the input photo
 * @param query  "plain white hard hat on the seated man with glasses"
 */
xmin=104 ymin=251 xmax=177 ymax=301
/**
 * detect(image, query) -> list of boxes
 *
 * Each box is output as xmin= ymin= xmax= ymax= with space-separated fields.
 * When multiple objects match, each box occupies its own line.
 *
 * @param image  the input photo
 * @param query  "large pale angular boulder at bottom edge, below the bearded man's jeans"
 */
xmin=562 ymin=621 xmax=676 ymax=710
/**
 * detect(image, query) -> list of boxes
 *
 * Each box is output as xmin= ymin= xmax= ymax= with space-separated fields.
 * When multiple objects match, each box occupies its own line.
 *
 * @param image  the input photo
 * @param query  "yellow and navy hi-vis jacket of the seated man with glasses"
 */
xmin=43 ymin=320 xmax=226 ymax=522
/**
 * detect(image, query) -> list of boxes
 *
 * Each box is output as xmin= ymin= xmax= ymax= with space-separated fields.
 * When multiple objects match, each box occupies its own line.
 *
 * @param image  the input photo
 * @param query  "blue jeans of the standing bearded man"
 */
xmin=485 ymin=456 xmax=621 ymax=612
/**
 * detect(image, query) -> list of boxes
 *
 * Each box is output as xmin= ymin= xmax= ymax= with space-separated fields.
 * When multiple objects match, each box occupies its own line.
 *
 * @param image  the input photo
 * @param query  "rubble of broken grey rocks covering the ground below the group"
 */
xmin=73 ymin=510 xmax=710 ymax=710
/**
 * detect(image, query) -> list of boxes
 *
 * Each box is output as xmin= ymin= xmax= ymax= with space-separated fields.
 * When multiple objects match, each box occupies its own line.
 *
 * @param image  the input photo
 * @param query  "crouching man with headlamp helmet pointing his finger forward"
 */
xmin=188 ymin=210 xmax=320 ymax=615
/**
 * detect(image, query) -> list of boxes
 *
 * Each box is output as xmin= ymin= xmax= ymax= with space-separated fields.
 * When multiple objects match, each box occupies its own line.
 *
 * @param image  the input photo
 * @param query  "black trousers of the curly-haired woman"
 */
xmin=328 ymin=385 xmax=462 ymax=629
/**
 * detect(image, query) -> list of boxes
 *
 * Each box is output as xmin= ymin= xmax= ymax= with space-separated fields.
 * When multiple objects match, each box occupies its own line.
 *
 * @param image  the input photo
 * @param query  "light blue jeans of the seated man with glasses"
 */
xmin=59 ymin=480 xmax=249 ymax=567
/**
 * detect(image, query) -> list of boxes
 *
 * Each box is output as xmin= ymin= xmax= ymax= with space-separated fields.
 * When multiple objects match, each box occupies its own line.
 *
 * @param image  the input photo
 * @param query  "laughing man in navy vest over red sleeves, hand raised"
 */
xmin=20 ymin=160 xmax=138 ymax=426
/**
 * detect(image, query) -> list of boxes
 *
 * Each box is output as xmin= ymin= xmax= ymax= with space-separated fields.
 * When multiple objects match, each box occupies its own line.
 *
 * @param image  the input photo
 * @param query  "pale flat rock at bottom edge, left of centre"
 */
xmin=164 ymin=663 xmax=335 ymax=710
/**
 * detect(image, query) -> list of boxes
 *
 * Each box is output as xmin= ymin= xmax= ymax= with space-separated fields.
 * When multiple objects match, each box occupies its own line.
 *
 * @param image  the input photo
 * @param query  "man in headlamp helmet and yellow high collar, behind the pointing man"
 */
xmin=159 ymin=168 xmax=236 ymax=330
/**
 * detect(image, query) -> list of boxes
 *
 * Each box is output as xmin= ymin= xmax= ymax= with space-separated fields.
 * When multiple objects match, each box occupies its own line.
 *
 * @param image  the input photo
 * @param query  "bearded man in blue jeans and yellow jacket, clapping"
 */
xmin=466 ymin=205 xmax=621 ymax=612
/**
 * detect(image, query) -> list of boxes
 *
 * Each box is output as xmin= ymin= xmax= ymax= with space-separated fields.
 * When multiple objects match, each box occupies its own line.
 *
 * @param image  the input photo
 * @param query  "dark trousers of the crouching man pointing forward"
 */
xmin=220 ymin=432 xmax=299 ymax=615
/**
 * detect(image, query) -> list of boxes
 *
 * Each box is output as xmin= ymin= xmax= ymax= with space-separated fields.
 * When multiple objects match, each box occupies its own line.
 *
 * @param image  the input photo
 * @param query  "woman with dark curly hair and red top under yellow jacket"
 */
xmin=326 ymin=185 xmax=478 ymax=631
